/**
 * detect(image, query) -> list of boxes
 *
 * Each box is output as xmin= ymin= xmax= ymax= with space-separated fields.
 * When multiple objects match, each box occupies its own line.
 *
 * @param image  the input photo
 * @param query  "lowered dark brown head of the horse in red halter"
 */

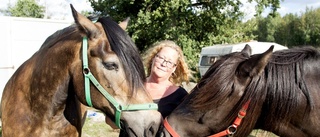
xmin=163 ymin=45 xmax=273 ymax=136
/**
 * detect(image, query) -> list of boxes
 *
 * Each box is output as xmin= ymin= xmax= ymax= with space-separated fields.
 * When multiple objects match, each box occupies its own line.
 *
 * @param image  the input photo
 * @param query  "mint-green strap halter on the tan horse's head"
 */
xmin=82 ymin=37 xmax=158 ymax=128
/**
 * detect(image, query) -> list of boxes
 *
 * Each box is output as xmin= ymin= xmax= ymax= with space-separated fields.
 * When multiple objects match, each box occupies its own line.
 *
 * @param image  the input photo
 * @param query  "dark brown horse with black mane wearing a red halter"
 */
xmin=163 ymin=45 xmax=320 ymax=137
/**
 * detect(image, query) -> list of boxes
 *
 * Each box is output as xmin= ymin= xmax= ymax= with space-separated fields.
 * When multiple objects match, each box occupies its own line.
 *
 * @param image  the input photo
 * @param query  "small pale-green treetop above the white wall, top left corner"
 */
xmin=5 ymin=0 xmax=44 ymax=18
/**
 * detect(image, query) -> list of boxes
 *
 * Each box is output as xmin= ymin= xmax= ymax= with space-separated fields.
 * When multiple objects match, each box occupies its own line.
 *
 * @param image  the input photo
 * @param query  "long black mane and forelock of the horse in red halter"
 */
xmin=189 ymin=47 xmax=320 ymax=136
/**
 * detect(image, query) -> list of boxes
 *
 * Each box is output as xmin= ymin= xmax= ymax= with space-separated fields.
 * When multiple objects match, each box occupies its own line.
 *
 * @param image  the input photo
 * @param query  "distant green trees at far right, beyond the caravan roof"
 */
xmin=253 ymin=7 xmax=320 ymax=47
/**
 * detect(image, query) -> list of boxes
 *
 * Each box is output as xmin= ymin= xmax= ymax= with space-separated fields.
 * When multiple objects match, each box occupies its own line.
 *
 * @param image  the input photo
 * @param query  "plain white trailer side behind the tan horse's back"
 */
xmin=0 ymin=16 xmax=73 ymax=100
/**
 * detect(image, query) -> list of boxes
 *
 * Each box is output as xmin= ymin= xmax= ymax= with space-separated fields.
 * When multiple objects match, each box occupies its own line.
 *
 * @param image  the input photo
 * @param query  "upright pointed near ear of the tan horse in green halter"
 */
xmin=70 ymin=4 xmax=99 ymax=38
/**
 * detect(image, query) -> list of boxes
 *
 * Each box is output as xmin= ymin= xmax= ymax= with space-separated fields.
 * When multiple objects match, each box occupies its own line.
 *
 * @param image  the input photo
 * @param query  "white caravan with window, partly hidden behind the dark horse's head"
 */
xmin=198 ymin=41 xmax=288 ymax=77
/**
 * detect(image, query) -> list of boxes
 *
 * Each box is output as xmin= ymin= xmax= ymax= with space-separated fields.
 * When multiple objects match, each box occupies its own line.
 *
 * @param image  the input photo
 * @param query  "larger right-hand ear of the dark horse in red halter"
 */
xmin=238 ymin=45 xmax=274 ymax=77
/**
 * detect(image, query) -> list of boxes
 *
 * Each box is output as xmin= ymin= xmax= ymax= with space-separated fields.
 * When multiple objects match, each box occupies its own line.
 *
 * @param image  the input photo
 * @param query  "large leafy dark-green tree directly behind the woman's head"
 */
xmin=89 ymin=0 xmax=280 ymax=79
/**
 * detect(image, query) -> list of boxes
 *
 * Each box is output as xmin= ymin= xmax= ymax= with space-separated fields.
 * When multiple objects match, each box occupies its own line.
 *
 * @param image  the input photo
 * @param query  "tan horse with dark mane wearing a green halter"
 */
xmin=1 ymin=5 xmax=161 ymax=137
